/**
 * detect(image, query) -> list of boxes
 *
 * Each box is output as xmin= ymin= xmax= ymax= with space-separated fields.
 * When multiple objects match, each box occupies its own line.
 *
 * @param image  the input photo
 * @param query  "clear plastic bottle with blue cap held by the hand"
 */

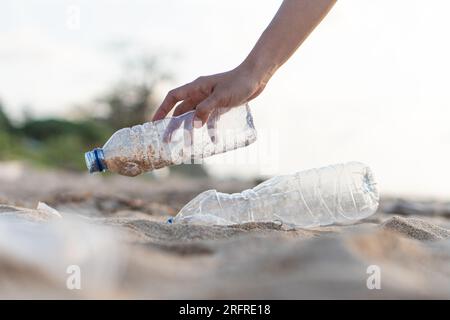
xmin=85 ymin=105 xmax=256 ymax=177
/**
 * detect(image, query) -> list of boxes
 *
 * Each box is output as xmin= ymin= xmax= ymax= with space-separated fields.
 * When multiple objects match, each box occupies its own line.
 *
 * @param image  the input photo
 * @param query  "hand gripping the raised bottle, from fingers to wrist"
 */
xmin=153 ymin=65 xmax=267 ymax=128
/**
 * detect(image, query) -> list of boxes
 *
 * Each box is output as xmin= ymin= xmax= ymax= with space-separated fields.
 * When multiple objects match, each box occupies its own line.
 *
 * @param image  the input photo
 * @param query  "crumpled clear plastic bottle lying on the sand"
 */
xmin=169 ymin=162 xmax=379 ymax=227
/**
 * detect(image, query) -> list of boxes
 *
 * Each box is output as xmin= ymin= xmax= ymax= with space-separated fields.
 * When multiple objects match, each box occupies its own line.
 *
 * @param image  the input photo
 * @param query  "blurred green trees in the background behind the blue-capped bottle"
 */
xmin=0 ymin=58 xmax=206 ymax=176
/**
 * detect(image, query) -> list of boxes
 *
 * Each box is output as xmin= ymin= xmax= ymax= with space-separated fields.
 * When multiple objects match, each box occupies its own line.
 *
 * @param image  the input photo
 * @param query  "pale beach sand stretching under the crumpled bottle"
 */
xmin=0 ymin=162 xmax=450 ymax=299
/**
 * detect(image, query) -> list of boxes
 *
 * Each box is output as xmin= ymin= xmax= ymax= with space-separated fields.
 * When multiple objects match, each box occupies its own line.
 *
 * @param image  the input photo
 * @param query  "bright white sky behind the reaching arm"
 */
xmin=0 ymin=0 xmax=450 ymax=197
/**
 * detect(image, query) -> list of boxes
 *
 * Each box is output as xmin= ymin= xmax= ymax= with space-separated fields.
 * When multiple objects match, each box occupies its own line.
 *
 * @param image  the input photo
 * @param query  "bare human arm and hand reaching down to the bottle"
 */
xmin=153 ymin=0 xmax=336 ymax=127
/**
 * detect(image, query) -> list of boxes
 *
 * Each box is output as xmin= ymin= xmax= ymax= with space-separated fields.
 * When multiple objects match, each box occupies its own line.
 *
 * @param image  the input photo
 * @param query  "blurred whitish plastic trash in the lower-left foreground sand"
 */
xmin=0 ymin=212 xmax=128 ymax=298
